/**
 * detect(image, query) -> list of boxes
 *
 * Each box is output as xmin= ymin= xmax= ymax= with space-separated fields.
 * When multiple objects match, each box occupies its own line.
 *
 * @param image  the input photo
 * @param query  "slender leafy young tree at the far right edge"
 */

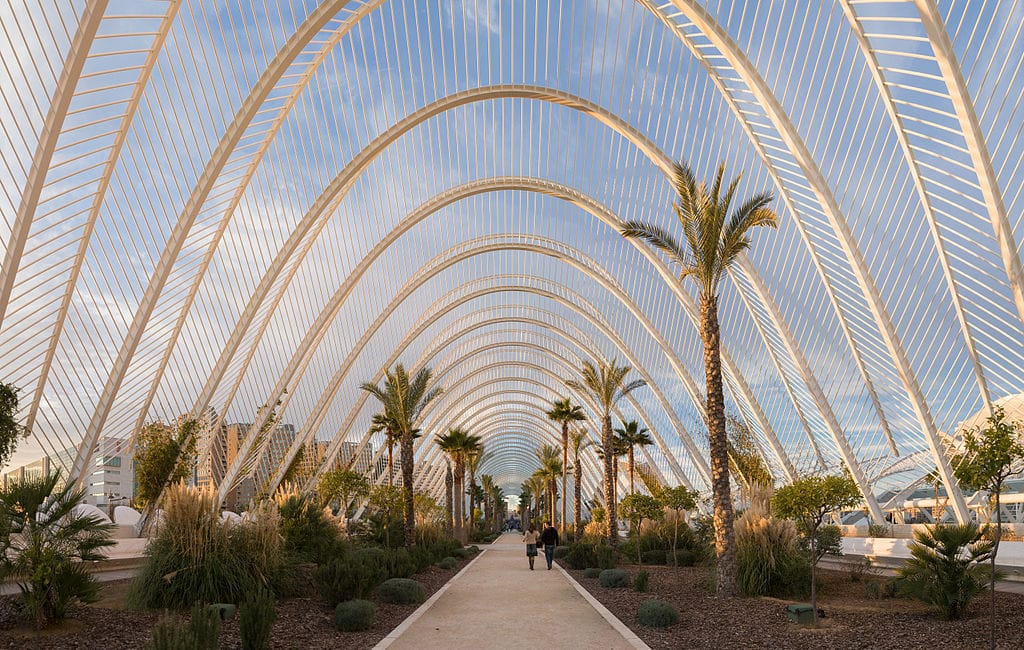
xmin=952 ymin=406 xmax=1024 ymax=648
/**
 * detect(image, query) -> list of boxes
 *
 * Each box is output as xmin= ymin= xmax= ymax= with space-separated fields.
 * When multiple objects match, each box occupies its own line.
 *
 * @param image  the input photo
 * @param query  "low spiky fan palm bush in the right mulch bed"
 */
xmin=897 ymin=523 xmax=992 ymax=619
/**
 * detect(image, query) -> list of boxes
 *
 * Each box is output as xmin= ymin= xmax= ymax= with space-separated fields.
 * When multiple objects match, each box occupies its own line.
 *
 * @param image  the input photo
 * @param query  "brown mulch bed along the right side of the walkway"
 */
xmin=562 ymin=563 xmax=1024 ymax=650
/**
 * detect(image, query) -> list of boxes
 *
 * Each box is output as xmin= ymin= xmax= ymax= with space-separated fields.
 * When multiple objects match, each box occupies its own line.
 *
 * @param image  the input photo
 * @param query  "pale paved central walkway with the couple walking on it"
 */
xmin=377 ymin=534 xmax=647 ymax=650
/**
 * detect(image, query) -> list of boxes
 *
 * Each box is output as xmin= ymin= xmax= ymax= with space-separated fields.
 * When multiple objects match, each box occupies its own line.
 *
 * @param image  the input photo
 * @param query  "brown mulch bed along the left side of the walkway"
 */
xmin=0 ymin=558 xmax=472 ymax=650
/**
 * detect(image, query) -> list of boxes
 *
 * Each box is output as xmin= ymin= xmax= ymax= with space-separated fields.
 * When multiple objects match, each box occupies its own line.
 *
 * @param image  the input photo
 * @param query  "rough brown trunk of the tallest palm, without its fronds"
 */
xmin=700 ymin=292 xmax=737 ymax=596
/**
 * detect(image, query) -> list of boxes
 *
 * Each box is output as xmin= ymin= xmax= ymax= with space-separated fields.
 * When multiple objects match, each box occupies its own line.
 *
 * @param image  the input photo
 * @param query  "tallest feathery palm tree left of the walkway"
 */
xmin=359 ymin=363 xmax=441 ymax=546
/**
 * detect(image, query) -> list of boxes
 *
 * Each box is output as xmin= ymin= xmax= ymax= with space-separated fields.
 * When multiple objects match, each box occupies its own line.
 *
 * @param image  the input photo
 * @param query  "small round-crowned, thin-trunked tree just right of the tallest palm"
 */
xmin=772 ymin=474 xmax=860 ymax=626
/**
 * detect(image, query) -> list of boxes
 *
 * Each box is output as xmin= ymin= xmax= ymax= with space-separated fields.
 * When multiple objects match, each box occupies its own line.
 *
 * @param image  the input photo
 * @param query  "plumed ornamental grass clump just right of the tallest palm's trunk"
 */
xmin=735 ymin=509 xmax=811 ymax=598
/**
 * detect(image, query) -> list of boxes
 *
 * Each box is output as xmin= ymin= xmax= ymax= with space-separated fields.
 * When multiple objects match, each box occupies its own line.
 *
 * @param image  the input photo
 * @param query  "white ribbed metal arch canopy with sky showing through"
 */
xmin=0 ymin=0 xmax=1024 ymax=520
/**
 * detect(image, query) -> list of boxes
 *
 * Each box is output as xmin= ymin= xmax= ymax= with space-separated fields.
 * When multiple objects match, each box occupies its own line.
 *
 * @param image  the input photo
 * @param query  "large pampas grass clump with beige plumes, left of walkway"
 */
xmin=128 ymin=485 xmax=285 ymax=609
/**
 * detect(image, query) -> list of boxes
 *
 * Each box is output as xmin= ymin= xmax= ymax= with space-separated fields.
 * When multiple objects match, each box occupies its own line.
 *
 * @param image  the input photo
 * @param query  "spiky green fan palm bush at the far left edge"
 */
xmin=0 ymin=474 xmax=114 ymax=627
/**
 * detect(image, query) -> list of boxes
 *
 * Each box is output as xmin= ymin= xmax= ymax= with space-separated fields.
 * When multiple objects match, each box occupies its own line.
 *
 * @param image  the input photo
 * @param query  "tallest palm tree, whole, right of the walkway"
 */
xmin=622 ymin=163 xmax=778 ymax=596
